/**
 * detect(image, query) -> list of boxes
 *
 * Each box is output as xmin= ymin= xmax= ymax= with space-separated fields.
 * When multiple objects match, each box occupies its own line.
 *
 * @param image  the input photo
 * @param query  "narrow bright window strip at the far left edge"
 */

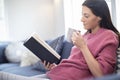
xmin=0 ymin=0 xmax=8 ymax=41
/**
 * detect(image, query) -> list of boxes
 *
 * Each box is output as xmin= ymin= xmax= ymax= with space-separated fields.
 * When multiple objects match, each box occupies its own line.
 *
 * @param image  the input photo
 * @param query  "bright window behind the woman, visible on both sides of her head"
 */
xmin=64 ymin=0 xmax=120 ymax=34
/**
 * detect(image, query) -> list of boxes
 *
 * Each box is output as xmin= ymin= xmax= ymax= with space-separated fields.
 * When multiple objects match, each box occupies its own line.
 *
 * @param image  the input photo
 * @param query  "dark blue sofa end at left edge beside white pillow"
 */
xmin=0 ymin=42 xmax=9 ymax=64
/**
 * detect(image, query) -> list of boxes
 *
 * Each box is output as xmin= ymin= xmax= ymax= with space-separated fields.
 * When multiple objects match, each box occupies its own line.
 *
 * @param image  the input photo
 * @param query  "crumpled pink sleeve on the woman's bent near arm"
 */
xmin=96 ymin=35 xmax=118 ymax=75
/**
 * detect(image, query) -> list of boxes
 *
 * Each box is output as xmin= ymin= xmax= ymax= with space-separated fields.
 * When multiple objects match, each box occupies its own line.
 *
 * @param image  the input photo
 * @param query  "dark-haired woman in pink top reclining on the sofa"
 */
xmin=0 ymin=0 xmax=120 ymax=80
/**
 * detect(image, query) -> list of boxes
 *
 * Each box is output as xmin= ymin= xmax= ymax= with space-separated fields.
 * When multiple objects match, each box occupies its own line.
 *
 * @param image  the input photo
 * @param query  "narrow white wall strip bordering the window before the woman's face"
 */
xmin=54 ymin=0 xmax=65 ymax=36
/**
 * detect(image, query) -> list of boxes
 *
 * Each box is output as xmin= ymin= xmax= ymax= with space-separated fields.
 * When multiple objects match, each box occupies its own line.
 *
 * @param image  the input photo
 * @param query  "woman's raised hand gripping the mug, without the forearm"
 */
xmin=72 ymin=31 xmax=86 ymax=49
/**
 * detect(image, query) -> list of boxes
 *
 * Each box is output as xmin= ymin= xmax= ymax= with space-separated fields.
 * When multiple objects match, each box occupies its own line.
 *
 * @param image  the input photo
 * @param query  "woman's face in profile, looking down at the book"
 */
xmin=81 ymin=6 xmax=101 ymax=30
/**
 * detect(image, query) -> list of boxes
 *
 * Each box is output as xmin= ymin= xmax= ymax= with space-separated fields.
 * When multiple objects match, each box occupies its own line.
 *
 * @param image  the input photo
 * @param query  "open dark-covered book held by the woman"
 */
xmin=23 ymin=33 xmax=61 ymax=64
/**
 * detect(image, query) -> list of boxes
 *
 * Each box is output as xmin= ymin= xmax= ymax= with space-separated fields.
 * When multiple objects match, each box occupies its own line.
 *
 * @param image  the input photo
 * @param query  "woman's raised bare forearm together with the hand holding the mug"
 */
xmin=72 ymin=32 xmax=103 ymax=77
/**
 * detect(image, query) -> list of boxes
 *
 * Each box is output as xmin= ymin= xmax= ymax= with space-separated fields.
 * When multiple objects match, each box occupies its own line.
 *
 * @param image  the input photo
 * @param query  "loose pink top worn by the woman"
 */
xmin=47 ymin=28 xmax=118 ymax=80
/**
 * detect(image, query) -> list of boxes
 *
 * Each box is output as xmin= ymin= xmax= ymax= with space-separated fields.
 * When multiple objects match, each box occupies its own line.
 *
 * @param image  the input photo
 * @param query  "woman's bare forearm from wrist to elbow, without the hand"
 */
xmin=80 ymin=46 xmax=103 ymax=77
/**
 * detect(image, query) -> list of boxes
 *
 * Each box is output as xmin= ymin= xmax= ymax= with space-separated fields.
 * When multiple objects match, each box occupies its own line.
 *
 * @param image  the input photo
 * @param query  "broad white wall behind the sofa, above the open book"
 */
xmin=5 ymin=0 xmax=64 ymax=40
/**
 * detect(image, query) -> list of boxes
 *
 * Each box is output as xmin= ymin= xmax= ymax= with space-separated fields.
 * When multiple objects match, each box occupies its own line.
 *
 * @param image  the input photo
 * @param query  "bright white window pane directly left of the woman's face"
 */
xmin=64 ymin=0 xmax=85 ymax=33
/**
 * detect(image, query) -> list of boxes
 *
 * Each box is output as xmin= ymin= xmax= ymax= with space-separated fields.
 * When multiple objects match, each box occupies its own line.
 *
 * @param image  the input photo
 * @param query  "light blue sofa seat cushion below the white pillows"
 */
xmin=0 ymin=63 xmax=45 ymax=76
